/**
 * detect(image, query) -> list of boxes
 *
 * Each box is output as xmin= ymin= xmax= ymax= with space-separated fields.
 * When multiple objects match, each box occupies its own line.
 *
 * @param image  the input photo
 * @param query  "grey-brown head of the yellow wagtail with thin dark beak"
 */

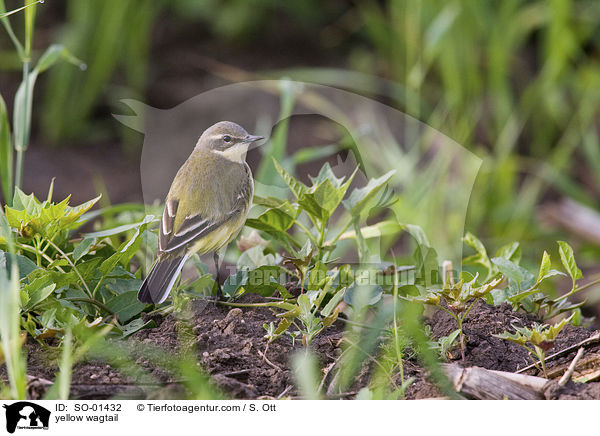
xmin=196 ymin=121 xmax=263 ymax=161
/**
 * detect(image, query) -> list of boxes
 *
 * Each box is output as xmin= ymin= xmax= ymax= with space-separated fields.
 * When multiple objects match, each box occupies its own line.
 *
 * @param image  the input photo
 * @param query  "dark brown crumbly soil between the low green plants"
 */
xmin=0 ymin=296 xmax=600 ymax=399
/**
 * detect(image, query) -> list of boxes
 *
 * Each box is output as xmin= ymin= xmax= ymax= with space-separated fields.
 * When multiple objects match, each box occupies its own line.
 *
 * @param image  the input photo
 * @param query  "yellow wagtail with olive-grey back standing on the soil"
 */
xmin=138 ymin=121 xmax=264 ymax=304
